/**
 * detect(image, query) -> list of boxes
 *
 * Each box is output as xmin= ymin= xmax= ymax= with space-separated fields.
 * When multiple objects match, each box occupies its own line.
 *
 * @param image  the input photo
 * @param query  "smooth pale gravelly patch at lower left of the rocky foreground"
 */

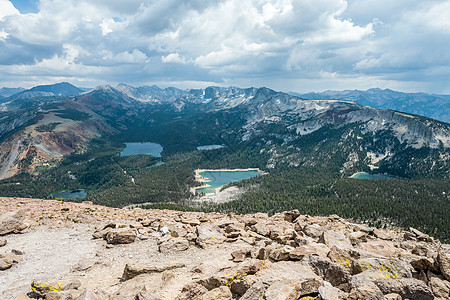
xmin=0 ymin=224 xmax=102 ymax=299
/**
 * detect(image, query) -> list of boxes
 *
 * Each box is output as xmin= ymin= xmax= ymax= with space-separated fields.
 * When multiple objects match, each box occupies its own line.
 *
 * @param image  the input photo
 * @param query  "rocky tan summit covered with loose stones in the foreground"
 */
xmin=0 ymin=198 xmax=450 ymax=300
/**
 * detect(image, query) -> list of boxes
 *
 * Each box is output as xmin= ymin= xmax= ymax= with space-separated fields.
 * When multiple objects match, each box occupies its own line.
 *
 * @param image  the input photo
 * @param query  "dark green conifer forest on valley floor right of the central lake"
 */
xmin=211 ymin=168 xmax=450 ymax=242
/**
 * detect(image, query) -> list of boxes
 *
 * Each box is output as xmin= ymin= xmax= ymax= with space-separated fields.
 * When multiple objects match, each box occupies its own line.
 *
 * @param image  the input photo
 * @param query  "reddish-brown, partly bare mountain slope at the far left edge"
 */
xmin=0 ymin=100 xmax=113 ymax=179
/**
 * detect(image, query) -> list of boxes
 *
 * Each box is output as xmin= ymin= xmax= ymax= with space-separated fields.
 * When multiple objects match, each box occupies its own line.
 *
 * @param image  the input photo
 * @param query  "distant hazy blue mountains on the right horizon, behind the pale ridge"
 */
xmin=291 ymin=88 xmax=450 ymax=123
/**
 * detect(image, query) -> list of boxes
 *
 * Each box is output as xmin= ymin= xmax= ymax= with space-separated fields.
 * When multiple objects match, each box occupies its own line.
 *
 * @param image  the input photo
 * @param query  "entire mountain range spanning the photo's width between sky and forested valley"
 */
xmin=0 ymin=83 xmax=450 ymax=178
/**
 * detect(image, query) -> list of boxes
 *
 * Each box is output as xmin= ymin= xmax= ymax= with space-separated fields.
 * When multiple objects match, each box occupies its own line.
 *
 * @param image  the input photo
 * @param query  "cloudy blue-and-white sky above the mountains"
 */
xmin=0 ymin=0 xmax=450 ymax=94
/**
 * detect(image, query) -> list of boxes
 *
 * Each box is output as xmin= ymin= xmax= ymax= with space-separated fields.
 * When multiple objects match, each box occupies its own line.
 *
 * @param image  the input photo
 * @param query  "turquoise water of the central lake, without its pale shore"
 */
xmin=197 ymin=170 xmax=260 ymax=194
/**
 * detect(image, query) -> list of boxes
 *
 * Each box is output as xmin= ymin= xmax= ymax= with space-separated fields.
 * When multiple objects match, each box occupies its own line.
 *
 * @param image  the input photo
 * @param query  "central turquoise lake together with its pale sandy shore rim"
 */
xmin=191 ymin=168 xmax=267 ymax=194
